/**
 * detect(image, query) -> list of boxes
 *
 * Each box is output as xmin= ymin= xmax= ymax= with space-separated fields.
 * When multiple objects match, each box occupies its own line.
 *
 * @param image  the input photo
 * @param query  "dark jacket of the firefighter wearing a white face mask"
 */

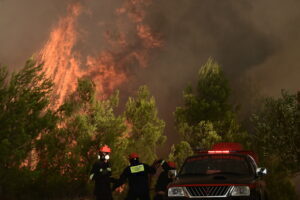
xmin=91 ymin=160 xmax=113 ymax=199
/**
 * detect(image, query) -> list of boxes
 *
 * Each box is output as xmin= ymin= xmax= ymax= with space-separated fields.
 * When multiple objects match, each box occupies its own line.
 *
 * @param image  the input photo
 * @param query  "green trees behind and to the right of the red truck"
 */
xmin=170 ymin=59 xmax=300 ymax=200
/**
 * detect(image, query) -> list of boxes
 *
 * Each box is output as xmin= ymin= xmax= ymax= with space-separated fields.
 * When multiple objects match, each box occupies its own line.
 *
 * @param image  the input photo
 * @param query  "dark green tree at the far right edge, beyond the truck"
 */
xmin=251 ymin=90 xmax=300 ymax=172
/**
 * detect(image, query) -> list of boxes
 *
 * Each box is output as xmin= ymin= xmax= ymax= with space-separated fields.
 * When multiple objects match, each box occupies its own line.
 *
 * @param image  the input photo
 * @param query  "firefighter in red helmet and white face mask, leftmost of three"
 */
xmin=90 ymin=145 xmax=113 ymax=200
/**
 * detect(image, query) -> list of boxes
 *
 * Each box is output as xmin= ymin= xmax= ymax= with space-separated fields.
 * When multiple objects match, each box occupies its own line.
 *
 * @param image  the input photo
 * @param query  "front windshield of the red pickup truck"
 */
xmin=179 ymin=154 xmax=253 ymax=176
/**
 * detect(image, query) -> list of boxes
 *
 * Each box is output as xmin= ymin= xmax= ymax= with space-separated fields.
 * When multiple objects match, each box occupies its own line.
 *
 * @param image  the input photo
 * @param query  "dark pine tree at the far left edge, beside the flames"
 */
xmin=0 ymin=59 xmax=55 ymax=168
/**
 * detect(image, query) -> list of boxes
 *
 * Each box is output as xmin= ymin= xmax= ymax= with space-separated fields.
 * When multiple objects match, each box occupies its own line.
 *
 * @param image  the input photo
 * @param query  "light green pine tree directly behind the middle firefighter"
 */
xmin=125 ymin=86 xmax=166 ymax=162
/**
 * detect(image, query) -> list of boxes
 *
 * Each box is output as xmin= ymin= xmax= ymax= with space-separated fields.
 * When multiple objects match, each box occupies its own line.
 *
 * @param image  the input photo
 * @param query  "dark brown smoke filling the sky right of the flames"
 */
xmin=135 ymin=0 xmax=300 ymax=155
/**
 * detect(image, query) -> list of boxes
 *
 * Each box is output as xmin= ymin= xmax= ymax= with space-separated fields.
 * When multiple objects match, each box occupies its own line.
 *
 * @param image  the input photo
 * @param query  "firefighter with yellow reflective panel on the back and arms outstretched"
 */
xmin=114 ymin=153 xmax=161 ymax=200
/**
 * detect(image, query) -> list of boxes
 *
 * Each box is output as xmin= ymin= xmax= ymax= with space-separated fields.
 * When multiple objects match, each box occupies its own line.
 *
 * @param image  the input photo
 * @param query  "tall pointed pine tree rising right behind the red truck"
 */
xmin=174 ymin=58 xmax=239 ymax=149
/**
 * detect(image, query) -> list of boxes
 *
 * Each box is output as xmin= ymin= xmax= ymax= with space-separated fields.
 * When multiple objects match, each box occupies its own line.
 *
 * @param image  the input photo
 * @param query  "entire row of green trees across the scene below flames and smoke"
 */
xmin=0 ymin=59 xmax=300 ymax=200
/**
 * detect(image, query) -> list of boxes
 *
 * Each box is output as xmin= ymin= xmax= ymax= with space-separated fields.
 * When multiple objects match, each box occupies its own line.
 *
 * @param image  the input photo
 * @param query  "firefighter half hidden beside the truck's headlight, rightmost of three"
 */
xmin=154 ymin=161 xmax=176 ymax=200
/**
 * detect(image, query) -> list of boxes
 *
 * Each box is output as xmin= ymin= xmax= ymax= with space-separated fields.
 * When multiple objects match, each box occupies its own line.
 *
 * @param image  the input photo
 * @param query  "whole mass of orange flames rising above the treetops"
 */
xmin=39 ymin=0 xmax=162 ymax=107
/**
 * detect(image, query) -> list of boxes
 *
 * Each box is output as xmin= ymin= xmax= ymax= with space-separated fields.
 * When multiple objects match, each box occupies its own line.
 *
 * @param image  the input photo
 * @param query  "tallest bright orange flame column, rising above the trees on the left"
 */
xmin=40 ymin=4 xmax=82 ymax=105
